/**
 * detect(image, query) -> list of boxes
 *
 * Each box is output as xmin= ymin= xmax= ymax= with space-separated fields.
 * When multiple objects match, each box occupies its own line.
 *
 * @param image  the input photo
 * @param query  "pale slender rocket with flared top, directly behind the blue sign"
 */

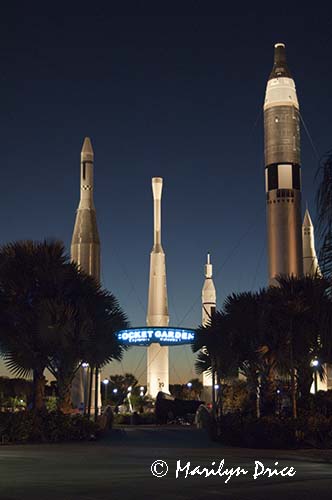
xmin=146 ymin=177 xmax=169 ymax=398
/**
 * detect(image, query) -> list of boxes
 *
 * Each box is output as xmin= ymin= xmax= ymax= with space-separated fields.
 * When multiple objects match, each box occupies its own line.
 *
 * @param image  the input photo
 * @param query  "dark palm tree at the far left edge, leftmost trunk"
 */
xmin=0 ymin=241 xmax=67 ymax=409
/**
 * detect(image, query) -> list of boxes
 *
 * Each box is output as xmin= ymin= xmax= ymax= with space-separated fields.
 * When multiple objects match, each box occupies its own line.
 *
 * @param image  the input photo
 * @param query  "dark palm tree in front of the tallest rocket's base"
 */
xmin=263 ymin=276 xmax=330 ymax=418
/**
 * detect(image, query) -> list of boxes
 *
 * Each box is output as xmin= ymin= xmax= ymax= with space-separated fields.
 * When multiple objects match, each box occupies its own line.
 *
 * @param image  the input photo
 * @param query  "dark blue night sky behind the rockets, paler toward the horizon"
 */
xmin=0 ymin=1 xmax=332 ymax=383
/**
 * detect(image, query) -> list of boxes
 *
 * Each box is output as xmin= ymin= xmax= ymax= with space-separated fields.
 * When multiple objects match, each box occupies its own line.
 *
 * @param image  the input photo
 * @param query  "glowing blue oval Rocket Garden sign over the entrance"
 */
xmin=116 ymin=327 xmax=195 ymax=346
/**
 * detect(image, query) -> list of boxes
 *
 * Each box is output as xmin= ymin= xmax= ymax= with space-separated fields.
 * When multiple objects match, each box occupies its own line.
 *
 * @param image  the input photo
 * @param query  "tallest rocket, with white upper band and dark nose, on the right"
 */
xmin=264 ymin=43 xmax=303 ymax=285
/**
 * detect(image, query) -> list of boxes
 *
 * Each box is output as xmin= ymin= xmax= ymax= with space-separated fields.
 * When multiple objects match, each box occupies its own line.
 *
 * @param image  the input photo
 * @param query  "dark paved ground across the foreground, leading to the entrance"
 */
xmin=0 ymin=426 xmax=332 ymax=500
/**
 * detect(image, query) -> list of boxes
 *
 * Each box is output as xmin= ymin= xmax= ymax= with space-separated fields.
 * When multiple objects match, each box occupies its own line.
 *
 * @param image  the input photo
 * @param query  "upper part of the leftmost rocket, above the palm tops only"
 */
xmin=71 ymin=137 xmax=100 ymax=282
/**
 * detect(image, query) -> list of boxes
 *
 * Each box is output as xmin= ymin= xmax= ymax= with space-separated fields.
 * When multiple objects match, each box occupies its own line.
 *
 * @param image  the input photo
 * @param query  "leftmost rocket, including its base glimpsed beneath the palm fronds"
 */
xmin=70 ymin=137 xmax=101 ymax=412
